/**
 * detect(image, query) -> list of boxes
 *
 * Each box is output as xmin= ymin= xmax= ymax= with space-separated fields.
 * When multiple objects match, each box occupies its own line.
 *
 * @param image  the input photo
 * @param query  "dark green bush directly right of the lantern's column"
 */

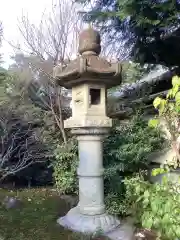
xmin=104 ymin=115 xmax=164 ymax=189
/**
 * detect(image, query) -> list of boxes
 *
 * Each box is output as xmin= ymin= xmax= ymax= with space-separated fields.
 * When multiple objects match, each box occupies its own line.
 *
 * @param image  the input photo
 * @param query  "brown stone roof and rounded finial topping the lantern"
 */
xmin=53 ymin=27 xmax=122 ymax=89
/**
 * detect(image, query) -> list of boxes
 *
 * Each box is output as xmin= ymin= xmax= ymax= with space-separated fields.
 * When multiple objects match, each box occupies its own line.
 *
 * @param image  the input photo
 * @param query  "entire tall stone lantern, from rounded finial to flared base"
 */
xmin=54 ymin=27 xmax=126 ymax=233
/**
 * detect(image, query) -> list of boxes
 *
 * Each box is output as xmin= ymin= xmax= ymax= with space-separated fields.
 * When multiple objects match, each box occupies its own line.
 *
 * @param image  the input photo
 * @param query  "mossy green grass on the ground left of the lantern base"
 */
xmin=0 ymin=188 xmax=107 ymax=240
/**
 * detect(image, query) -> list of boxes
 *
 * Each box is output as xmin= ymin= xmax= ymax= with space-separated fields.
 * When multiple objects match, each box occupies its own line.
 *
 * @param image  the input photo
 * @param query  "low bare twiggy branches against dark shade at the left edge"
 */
xmin=0 ymin=110 xmax=50 ymax=181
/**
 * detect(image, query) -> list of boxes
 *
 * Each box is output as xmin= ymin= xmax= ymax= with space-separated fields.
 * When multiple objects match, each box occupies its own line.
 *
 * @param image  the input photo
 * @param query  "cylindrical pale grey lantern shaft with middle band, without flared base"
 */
xmin=77 ymin=135 xmax=105 ymax=215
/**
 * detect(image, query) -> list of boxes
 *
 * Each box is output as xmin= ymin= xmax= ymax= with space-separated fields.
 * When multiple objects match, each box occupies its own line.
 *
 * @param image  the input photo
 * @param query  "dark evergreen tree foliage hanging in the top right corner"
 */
xmin=77 ymin=0 xmax=180 ymax=66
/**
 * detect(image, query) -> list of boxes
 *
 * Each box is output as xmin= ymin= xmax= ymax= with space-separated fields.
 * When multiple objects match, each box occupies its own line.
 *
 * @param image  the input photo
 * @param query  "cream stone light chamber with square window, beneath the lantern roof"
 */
xmin=64 ymin=84 xmax=112 ymax=128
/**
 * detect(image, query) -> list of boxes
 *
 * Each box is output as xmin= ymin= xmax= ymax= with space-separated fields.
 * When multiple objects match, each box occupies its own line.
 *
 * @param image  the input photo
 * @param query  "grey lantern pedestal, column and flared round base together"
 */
xmin=58 ymin=128 xmax=120 ymax=233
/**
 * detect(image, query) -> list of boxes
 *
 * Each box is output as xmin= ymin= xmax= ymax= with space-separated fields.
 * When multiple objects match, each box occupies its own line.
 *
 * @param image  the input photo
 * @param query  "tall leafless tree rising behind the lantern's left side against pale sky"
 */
xmin=8 ymin=0 xmax=83 ymax=142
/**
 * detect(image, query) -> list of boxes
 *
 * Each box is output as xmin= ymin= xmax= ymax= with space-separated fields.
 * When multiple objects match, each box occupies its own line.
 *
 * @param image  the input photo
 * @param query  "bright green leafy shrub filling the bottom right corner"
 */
xmin=121 ymin=172 xmax=180 ymax=240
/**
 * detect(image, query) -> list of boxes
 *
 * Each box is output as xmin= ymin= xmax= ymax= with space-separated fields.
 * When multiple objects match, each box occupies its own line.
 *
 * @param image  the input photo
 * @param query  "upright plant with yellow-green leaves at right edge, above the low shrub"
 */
xmin=149 ymin=76 xmax=180 ymax=168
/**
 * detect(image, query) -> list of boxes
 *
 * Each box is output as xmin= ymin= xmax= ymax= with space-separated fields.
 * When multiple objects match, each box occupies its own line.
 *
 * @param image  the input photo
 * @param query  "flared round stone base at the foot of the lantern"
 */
xmin=57 ymin=206 xmax=120 ymax=234
